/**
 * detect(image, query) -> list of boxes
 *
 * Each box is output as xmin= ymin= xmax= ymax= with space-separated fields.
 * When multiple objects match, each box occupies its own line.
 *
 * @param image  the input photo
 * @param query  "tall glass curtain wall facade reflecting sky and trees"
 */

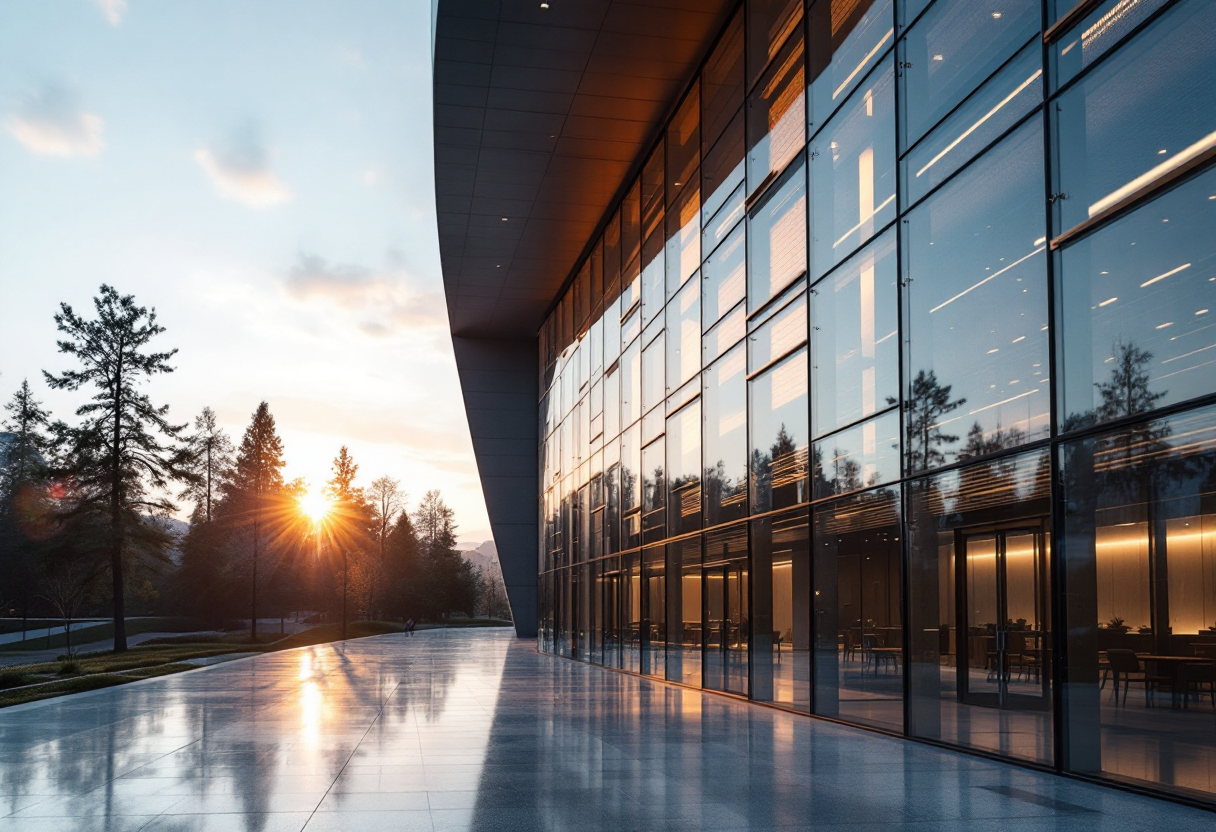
xmin=537 ymin=0 xmax=1216 ymax=802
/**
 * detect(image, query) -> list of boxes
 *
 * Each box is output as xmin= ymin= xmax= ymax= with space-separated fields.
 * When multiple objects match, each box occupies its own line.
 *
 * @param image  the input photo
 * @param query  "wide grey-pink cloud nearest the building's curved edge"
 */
xmin=283 ymin=252 xmax=447 ymax=337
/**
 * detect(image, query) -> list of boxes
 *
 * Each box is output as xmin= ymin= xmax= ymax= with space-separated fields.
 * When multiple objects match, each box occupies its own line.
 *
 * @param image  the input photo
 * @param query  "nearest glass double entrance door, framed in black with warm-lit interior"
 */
xmin=956 ymin=527 xmax=1049 ymax=710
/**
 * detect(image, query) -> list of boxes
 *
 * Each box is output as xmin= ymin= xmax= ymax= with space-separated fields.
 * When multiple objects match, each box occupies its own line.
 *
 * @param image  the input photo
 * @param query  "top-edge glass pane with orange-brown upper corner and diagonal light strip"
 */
xmin=806 ymin=0 xmax=895 ymax=131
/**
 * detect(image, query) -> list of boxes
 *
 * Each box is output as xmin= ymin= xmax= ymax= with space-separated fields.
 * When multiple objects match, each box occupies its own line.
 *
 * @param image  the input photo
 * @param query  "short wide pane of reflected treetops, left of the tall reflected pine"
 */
xmin=812 ymin=410 xmax=900 ymax=499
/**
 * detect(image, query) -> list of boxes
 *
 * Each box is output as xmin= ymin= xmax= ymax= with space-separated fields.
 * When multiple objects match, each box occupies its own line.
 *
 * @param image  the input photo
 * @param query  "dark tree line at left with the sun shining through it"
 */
xmin=0 ymin=285 xmax=508 ymax=651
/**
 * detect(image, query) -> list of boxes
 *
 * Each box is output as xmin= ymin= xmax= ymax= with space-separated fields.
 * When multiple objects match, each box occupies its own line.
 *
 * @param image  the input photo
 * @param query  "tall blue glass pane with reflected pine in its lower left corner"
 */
xmin=903 ymin=119 xmax=1051 ymax=471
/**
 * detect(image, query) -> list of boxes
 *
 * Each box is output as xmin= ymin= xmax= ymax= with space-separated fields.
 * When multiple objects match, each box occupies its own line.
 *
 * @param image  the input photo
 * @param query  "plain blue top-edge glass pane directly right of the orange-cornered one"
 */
xmin=900 ymin=0 xmax=1041 ymax=147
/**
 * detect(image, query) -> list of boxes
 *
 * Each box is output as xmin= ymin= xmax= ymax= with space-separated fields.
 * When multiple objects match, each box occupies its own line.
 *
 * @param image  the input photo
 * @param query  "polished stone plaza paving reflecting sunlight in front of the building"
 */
xmin=0 ymin=630 xmax=1216 ymax=832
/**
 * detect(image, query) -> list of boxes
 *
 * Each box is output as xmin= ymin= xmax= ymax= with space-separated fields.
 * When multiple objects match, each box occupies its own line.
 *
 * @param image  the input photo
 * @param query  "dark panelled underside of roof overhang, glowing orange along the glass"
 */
xmin=434 ymin=0 xmax=736 ymax=339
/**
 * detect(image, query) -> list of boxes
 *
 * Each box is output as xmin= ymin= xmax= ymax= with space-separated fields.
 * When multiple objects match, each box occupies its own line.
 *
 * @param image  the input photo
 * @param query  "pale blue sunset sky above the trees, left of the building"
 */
xmin=0 ymin=0 xmax=490 ymax=543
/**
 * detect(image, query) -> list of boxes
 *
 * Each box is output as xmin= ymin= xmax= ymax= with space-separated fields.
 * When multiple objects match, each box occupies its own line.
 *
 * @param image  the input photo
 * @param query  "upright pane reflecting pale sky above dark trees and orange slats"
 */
xmin=748 ymin=348 xmax=810 ymax=513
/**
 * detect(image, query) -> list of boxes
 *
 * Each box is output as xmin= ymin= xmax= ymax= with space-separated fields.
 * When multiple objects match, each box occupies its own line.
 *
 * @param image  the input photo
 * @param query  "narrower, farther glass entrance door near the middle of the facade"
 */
xmin=702 ymin=560 xmax=751 ymax=696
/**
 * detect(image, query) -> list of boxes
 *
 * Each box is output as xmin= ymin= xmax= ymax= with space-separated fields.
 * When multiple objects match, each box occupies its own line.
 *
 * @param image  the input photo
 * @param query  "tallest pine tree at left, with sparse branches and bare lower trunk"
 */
xmin=43 ymin=285 xmax=192 ymax=652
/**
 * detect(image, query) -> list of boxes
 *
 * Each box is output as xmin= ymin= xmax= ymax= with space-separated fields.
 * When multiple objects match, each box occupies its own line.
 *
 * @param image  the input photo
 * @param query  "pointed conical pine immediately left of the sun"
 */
xmin=227 ymin=401 xmax=285 ymax=641
